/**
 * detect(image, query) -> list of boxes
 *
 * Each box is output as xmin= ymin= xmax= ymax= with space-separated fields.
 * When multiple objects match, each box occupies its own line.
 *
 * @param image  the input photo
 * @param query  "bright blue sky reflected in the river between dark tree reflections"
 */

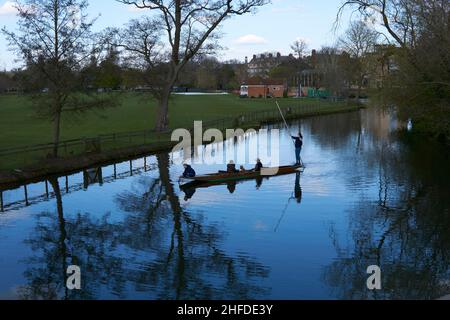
xmin=0 ymin=108 xmax=450 ymax=299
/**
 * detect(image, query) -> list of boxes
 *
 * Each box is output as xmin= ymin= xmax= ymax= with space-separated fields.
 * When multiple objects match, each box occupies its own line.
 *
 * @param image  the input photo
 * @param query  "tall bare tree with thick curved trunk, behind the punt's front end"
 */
xmin=117 ymin=0 xmax=269 ymax=131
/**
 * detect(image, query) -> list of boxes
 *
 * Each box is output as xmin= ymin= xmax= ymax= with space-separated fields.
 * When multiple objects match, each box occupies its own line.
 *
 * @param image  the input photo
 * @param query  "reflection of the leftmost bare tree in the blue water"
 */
xmin=19 ymin=179 xmax=125 ymax=300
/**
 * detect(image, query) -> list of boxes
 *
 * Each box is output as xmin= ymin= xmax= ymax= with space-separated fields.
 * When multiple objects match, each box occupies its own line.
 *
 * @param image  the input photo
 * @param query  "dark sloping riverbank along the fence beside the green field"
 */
xmin=0 ymin=94 xmax=360 ymax=188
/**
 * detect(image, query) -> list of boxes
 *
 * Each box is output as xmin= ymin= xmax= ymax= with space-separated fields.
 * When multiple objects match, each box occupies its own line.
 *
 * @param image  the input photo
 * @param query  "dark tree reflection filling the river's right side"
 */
xmin=323 ymin=130 xmax=450 ymax=299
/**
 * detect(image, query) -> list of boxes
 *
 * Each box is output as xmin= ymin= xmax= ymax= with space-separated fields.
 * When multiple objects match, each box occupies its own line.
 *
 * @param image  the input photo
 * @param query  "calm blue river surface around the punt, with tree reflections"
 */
xmin=0 ymin=109 xmax=450 ymax=299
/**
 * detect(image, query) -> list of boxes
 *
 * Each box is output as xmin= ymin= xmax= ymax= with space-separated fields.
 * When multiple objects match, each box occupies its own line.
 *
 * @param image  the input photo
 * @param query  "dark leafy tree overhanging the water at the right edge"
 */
xmin=337 ymin=0 xmax=450 ymax=141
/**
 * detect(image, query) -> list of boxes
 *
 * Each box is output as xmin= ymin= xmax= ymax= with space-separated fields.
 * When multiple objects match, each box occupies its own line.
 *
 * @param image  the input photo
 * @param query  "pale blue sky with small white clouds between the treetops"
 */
xmin=0 ymin=0 xmax=349 ymax=69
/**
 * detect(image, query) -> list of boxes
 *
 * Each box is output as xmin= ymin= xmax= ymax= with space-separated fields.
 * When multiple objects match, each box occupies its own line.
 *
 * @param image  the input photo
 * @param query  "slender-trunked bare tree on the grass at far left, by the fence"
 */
xmin=2 ymin=0 xmax=112 ymax=157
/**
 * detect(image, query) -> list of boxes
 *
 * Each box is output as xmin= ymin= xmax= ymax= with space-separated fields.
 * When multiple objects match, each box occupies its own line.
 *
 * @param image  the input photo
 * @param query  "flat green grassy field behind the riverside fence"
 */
xmin=0 ymin=94 xmax=350 ymax=150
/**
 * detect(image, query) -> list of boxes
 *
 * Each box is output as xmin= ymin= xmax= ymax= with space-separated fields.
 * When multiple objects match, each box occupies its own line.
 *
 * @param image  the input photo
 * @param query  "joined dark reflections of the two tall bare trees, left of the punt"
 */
xmin=19 ymin=155 xmax=269 ymax=299
